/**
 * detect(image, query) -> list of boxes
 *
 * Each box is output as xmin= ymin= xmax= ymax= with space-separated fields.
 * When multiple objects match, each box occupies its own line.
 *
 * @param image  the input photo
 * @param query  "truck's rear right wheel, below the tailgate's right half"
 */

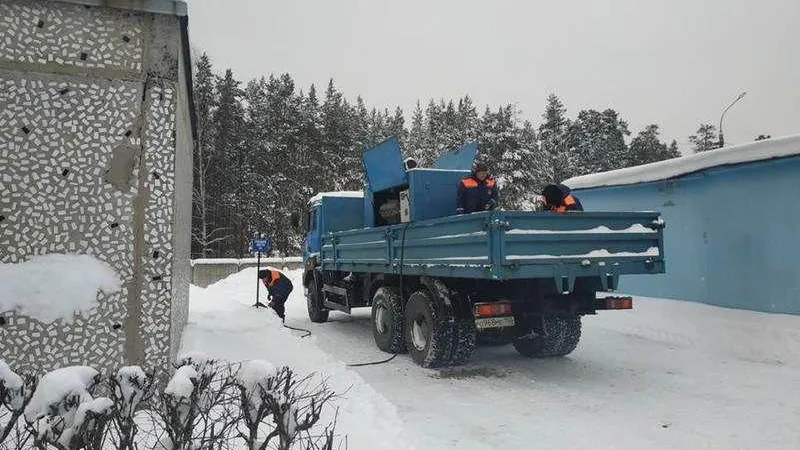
xmin=513 ymin=316 xmax=581 ymax=358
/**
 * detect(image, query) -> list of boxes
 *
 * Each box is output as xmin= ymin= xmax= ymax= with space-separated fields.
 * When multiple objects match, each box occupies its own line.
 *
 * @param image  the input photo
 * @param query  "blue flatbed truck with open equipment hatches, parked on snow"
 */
xmin=303 ymin=138 xmax=665 ymax=367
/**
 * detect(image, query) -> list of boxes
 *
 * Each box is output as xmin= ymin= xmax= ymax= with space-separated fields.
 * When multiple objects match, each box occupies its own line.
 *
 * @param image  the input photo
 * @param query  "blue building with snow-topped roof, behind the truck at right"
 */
xmin=564 ymin=135 xmax=800 ymax=314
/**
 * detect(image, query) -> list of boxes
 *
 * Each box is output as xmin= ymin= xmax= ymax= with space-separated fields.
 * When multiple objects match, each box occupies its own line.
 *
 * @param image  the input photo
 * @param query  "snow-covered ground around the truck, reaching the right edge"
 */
xmin=183 ymin=269 xmax=800 ymax=450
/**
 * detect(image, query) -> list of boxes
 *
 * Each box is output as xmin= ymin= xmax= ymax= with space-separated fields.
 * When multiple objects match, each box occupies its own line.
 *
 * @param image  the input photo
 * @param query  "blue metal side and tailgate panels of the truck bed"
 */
xmin=321 ymin=211 xmax=664 ymax=280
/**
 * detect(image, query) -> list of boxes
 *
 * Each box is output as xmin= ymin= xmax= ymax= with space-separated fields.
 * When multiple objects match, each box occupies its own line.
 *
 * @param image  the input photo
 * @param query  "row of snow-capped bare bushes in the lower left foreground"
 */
xmin=0 ymin=360 xmax=339 ymax=450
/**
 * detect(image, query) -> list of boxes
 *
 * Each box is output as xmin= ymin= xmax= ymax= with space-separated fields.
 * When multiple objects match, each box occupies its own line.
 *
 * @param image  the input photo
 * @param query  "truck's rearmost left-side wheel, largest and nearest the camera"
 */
xmin=405 ymin=291 xmax=454 ymax=367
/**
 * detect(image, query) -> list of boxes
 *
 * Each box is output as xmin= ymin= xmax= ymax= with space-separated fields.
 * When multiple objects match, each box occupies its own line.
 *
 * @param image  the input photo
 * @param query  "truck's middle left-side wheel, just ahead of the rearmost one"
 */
xmin=372 ymin=286 xmax=406 ymax=353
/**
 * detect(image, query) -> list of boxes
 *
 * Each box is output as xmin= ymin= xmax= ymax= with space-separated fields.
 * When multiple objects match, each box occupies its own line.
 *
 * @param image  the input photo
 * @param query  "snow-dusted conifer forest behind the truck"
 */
xmin=192 ymin=55 xmax=680 ymax=257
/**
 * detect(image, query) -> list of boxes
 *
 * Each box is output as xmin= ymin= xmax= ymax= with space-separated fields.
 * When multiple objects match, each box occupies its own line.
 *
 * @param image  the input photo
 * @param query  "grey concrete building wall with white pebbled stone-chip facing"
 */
xmin=0 ymin=0 xmax=191 ymax=370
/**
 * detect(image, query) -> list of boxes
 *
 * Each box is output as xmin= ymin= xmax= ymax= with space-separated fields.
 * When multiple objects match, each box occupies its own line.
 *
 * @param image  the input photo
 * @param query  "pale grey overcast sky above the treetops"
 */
xmin=188 ymin=0 xmax=800 ymax=151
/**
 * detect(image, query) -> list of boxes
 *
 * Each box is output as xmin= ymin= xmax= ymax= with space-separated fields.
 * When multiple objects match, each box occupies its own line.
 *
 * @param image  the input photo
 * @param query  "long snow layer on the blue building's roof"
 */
xmin=564 ymin=135 xmax=800 ymax=189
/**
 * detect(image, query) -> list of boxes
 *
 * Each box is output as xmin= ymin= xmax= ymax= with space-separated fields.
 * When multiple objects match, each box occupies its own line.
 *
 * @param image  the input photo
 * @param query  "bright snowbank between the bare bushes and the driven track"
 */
xmin=181 ymin=268 xmax=413 ymax=450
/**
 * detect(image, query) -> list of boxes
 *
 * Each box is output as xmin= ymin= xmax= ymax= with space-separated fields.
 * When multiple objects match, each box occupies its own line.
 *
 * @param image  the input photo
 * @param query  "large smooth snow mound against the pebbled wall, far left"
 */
xmin=0 ymin=253 xmax=122 ymax=323
